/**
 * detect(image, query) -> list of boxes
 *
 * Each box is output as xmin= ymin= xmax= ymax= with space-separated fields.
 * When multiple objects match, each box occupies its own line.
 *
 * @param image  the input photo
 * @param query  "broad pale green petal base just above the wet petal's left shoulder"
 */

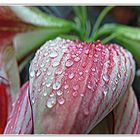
xmin=13 ymin=28 xmax=69 ymax=63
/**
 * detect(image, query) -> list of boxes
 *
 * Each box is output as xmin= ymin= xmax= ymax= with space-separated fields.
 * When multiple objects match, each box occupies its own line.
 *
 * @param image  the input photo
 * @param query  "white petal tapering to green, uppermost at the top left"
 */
xmin=10 ymin=6 xmax=73 ymax=27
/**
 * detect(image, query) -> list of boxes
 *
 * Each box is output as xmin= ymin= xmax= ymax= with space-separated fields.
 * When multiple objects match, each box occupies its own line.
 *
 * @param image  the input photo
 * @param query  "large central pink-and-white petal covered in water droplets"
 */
xmin=30 ymin=38 xmax=135 ymax=133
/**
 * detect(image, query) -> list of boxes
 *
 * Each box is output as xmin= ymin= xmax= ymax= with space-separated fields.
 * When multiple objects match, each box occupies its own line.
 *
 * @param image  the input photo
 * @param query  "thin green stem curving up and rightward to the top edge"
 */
xmin=90 ymin=6 xmax=113 ymax=40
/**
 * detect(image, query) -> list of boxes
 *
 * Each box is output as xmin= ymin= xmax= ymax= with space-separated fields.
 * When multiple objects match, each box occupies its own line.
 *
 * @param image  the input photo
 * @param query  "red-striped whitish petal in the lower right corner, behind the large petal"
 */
xmin=113 ymin=88 xmax=140 ymax=134
